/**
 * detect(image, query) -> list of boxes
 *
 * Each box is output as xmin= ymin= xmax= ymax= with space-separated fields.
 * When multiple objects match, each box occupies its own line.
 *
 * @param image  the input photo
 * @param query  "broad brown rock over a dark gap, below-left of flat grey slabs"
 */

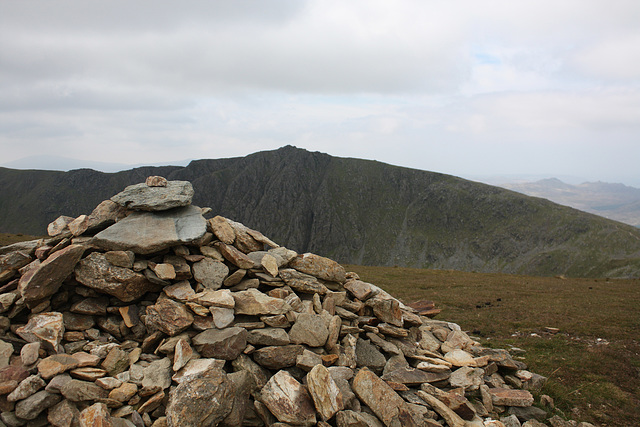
xmin=75 ymin=252 xmax=157 ymax=302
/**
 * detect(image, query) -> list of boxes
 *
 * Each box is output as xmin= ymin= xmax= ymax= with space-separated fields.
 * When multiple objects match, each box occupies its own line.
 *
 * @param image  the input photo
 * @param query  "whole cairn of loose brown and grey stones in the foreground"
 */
xmin=0 ymin=177 xmax=588 ymax=427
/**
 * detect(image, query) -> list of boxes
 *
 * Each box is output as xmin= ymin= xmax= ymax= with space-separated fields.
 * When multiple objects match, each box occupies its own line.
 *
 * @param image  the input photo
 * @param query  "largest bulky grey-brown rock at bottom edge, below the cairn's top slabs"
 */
xmin=166 ymin=369 xmax=234 ymax=427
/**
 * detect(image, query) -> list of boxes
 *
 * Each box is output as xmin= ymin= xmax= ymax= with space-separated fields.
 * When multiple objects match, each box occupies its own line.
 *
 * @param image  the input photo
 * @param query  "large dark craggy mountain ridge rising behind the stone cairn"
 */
xmin=0 ymin=146 xmax=640 ymax=277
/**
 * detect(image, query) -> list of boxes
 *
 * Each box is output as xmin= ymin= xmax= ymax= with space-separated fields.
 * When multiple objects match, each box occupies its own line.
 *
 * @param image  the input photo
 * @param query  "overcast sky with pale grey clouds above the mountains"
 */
xmin=0 ymin=0 xmax=640 ymax=186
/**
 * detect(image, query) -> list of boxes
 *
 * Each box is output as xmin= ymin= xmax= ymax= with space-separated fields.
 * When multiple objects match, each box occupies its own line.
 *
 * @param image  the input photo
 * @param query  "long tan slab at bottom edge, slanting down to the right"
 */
xmin=352 ymin=368 xmax=416 ymax=426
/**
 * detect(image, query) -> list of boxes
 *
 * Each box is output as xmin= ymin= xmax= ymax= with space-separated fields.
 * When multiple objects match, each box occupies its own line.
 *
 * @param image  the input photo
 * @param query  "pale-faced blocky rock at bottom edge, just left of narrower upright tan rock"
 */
xmin=260 ymin=371 xmax=316 ymax=426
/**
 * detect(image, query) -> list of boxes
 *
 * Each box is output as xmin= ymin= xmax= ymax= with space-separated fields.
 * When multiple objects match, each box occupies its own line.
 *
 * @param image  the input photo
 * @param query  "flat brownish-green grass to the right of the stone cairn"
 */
xmin=346 ymin=265 xmax=640 ymax=426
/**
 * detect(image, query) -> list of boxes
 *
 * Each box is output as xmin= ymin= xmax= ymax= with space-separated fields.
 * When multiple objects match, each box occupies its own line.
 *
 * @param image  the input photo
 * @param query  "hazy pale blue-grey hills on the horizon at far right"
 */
xmin=500 ymin=178 xmax=640 ymax=227
